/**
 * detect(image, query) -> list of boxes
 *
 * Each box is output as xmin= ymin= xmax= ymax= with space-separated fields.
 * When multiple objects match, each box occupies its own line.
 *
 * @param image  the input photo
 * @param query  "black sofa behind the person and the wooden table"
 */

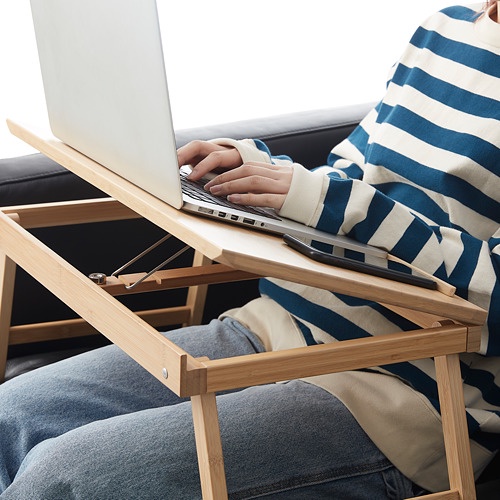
xmin=0 ymin=103 xmax=500 ymax=499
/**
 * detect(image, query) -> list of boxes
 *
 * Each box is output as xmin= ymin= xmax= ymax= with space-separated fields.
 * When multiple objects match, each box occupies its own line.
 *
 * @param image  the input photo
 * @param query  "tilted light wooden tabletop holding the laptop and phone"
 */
xmin=8 ymin=120 xmax=486 ymax=325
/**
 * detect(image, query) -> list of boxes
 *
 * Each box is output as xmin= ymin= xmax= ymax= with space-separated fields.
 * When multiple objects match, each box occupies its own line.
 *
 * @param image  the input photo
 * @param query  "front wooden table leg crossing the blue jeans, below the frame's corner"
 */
xmin=191 ymin=392 xmax=227 ymax=500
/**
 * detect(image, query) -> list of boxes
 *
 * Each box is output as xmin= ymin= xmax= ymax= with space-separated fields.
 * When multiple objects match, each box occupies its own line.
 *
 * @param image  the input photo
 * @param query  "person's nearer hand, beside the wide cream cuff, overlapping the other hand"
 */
xmin=205 ymin=162 xmax=293 ymax=210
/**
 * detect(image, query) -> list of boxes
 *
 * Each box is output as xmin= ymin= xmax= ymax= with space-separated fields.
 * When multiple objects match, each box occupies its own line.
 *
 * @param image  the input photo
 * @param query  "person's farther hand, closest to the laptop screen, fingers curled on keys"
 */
xmin=177 ymin=141 xmax=243 ymax=181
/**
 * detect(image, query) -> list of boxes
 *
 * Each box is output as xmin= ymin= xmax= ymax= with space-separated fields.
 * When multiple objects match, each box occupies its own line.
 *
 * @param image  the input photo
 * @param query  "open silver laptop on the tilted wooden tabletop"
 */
xmin=31 ymin=0 xmax=386 ymax=258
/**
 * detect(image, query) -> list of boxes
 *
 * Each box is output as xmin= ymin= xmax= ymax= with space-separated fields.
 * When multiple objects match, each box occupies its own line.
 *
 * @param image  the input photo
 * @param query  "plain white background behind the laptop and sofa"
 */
xmin=0 ymin=0 xmax=469 ymax=158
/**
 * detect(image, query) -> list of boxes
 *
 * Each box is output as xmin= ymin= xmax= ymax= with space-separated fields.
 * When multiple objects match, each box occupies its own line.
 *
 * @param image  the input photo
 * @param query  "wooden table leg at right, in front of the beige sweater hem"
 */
xmin=434 ymin=354 xmax=476 ymax=500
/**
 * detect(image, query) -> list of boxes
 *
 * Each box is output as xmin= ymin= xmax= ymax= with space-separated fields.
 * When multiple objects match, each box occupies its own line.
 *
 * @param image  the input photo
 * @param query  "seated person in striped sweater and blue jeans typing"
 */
xmin=0 ymin=0 xmax=500 ymax=500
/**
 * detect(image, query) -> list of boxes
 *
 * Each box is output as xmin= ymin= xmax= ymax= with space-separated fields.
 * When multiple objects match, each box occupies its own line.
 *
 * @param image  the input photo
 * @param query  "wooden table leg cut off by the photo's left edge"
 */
xmin=0 ymin=253 xmax=16 ymax=383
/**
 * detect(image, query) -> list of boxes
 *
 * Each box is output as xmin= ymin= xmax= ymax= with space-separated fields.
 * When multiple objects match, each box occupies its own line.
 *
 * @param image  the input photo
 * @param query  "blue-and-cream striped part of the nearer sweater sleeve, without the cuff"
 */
xmin=322 ymin=176 xmax=500 ymax=348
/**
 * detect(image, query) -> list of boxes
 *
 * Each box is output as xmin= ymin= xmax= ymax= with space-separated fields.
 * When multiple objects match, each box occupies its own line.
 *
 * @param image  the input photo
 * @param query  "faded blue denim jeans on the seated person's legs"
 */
xmin=0 ymin=320 xmax=420 ymax=500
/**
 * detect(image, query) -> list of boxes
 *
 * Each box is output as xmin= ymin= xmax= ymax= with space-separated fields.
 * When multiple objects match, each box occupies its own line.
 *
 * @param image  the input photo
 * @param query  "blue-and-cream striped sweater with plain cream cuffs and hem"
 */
xmin=218 ymin=2 xmax=500 ymax=490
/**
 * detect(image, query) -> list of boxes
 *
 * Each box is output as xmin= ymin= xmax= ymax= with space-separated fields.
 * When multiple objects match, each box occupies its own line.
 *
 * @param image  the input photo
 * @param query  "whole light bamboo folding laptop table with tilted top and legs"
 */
xmin=0 ymin=121 xmax=486 ymax=500
